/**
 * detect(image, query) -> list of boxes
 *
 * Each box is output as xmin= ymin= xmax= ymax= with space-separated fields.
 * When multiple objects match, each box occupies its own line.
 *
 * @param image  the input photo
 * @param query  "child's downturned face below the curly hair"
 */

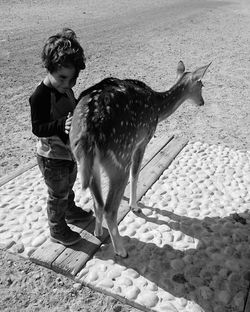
xmin=48 ymin=66 xmax=78 ymax=93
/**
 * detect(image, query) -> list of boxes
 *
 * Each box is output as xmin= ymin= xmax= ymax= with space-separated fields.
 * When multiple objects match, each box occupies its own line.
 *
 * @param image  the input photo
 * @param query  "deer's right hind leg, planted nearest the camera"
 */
xmin=104 ymin=162 xmax=129 ymax=257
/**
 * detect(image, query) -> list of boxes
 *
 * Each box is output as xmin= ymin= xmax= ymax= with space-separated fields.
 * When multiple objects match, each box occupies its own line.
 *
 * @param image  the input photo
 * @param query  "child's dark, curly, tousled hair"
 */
xmin=42 ymin=28 xmax=86 ymax=73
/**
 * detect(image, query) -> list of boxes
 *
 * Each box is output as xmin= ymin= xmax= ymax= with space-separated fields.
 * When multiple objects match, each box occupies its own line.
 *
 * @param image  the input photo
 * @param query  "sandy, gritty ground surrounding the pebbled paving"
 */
xmin=0 ymin=0 xmax=250 ymax=312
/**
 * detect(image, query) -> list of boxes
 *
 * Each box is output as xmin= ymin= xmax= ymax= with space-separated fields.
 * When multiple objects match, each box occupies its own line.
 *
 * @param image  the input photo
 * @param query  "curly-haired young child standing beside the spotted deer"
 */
xmin=29 ymin=28 xmax=92 ymax=246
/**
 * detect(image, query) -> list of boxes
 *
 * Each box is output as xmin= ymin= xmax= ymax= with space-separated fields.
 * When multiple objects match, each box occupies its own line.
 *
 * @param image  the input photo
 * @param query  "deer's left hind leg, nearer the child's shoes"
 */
xmin=89 ymin=161 xmax=104 ymax=236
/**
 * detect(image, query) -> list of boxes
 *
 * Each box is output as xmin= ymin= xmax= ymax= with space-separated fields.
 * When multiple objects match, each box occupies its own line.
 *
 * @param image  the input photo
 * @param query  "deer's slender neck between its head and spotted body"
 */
xmin=156 ymin=84 xmax=187 ymax=122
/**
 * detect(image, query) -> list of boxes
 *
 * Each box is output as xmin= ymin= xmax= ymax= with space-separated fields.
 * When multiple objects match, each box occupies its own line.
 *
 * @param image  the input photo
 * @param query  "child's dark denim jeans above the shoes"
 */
xmin=37 ymin=155 xmax=77 ymax=235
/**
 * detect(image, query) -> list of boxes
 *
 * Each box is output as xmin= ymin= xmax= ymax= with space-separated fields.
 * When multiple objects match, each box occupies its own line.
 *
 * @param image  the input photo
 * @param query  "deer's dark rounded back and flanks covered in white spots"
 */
xmin=72 ymin=78 xmax=157 ymax=161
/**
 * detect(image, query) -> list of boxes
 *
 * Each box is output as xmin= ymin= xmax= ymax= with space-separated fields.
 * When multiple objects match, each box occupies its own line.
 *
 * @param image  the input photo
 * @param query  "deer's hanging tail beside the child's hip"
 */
xmin=71 ymin=135 xmax=95 ymax=189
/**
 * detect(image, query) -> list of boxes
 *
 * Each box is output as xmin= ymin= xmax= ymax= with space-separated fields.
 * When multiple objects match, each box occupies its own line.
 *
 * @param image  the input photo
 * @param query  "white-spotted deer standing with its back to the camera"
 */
xmin=70 ymin=61 xmax=210 ymax=257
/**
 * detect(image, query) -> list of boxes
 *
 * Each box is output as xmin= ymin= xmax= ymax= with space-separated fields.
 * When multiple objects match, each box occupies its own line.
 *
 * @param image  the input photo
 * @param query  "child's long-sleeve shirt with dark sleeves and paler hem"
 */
xmin=29 ymin=82 xmax=76 ymax=160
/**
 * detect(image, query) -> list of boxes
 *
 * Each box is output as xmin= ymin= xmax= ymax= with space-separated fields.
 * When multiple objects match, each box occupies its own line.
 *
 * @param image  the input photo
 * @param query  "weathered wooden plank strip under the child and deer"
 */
xmin=30 ymin=136 xmax=187 ymax=278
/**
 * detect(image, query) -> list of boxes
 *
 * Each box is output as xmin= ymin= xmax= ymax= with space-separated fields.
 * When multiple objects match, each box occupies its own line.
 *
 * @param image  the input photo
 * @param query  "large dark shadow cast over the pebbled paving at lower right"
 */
xmin=97 ymin=202 xmax=250 ymax=312
